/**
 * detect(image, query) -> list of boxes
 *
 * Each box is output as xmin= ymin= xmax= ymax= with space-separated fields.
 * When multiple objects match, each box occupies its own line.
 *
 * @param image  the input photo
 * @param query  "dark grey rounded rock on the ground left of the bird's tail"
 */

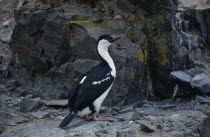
xmin=20 ymin=98 xmax=41 ymax=112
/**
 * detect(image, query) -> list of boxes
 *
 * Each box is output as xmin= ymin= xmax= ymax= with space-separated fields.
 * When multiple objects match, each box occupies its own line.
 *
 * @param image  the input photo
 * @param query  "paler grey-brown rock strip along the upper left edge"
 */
xmin=0 ymin=0 xmax=17 ymax=82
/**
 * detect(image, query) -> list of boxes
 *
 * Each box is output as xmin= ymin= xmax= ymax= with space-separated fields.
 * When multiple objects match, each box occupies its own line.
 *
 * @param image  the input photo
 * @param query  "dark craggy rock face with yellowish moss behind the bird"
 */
xmin=6 ymin=0 xmax=210 ymax=105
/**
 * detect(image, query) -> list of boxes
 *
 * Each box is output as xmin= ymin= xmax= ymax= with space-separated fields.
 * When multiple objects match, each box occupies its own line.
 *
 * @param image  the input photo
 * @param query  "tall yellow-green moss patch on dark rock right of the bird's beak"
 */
xmin=145 ymin=15 xmax=169 ymax=69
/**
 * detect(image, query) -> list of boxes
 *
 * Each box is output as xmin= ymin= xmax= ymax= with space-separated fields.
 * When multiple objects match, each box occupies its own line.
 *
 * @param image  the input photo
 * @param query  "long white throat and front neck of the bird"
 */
xmin=98 ymin=40 xmax=116 ymax=77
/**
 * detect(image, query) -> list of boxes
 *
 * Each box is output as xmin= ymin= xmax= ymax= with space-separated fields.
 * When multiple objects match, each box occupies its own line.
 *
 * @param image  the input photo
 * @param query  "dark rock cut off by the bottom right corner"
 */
xmin=198 ymin=116 xmax=210 ymax=137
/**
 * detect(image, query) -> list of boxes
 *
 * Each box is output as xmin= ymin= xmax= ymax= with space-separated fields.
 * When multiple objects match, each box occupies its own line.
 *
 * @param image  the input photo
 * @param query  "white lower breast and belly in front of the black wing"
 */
xmin=93 ymin=85 xmax=112 ymax=113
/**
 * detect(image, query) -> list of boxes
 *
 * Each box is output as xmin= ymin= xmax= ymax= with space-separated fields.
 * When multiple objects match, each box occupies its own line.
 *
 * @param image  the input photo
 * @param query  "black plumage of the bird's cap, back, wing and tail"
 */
xmin=59 ymin=35 xmax=119 ymax=128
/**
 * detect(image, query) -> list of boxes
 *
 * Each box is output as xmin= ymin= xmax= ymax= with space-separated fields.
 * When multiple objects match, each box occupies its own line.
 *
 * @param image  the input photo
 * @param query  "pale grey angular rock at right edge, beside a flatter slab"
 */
xmin=191 ymin=73 xmax=210 ymax=94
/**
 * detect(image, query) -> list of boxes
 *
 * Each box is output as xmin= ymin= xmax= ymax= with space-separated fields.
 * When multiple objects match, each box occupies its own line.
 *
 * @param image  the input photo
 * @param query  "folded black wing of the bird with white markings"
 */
xmin=69 ymin=64 xmax=114 ymax=110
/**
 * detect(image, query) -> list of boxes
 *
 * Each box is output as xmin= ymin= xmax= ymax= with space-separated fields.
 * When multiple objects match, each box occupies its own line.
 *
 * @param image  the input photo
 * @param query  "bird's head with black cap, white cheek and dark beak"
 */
xmin=97 ymin=35 xmax=121 ymax=48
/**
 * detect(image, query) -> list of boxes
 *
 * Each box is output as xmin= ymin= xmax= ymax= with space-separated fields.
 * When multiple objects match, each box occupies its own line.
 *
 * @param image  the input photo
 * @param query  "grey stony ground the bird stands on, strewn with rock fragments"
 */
xmin=0 ymin=82 xmax=210 ymax=137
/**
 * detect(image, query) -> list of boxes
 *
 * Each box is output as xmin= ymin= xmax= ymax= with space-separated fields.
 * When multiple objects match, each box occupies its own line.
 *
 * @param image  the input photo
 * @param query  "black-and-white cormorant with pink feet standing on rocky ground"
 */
xmin=59 ymin=34 xmax=121 ymax=128
